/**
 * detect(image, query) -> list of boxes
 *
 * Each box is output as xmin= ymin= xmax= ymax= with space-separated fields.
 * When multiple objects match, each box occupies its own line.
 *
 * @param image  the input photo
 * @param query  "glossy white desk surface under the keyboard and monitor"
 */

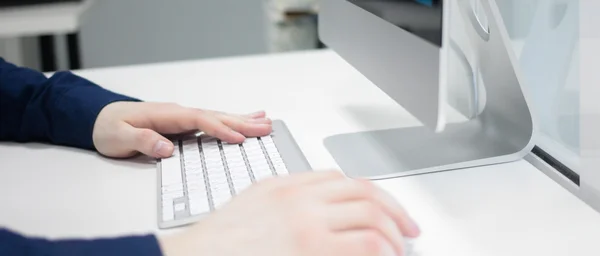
xmin=0 ymin=51 xmax=600 ymax=256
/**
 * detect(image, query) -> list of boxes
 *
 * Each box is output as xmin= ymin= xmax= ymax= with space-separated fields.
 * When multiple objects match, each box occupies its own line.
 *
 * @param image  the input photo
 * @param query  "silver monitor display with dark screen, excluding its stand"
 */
xmin=319 ymin=0 xmax=450 ymax=132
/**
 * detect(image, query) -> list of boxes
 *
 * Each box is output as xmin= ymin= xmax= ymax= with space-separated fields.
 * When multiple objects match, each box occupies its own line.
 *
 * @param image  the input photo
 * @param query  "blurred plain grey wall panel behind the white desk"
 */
xmin=80 ymin=0 xmax=267 ymax=68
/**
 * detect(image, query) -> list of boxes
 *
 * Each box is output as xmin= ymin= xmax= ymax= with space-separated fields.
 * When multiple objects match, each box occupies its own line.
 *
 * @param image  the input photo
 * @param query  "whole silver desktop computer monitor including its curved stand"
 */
xmin=319 ymin=0 xmax=535 ymax=179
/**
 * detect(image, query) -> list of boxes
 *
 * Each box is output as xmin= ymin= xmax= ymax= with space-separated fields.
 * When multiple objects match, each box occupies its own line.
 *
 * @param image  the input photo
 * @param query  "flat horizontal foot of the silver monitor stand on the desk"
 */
xmin=325 ymin=120 xmax=528 ymax=179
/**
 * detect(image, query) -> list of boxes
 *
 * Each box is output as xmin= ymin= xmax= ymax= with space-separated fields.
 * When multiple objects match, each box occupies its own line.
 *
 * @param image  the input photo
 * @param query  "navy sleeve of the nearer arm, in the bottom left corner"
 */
xmin=0 ymin=229 xmax=162 ymax=256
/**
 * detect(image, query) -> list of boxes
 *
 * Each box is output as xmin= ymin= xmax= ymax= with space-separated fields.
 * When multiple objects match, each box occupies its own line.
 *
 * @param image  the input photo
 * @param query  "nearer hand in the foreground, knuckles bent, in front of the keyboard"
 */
xmin=159 ymin=172 xmax=420 ymax=256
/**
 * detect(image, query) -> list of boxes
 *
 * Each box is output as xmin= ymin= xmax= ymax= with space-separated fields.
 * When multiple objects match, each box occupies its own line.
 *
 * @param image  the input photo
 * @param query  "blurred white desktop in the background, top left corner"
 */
xmin=0 ymin=0 xmax=92 ymax=37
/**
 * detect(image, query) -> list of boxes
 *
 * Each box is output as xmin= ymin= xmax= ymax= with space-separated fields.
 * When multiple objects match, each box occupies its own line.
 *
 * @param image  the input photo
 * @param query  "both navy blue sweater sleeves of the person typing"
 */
xmin=0 ymin=58 xmax=161 ymax=256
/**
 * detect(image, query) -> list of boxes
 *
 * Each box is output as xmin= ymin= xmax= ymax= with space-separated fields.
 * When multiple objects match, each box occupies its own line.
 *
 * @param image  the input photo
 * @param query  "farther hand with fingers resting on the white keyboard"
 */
xmin=92 ymin=102 xmax=272 ymax=158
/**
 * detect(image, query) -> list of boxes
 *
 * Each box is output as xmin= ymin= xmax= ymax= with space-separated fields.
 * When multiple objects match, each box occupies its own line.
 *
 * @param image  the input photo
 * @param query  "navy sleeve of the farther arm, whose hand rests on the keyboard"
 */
xmin=0 ymin=58 xmax=138 ymax=149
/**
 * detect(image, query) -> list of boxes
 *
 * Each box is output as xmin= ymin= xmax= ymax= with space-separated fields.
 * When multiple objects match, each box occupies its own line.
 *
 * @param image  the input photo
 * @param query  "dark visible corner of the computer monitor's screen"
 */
xmin=348 ymin=0 xmax=443 ymax=47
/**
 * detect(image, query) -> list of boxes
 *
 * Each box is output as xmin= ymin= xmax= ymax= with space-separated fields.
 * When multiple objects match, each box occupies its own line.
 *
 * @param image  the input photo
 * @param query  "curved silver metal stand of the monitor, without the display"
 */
xmin=325 ymin=0 xmax=535 ymax=179
